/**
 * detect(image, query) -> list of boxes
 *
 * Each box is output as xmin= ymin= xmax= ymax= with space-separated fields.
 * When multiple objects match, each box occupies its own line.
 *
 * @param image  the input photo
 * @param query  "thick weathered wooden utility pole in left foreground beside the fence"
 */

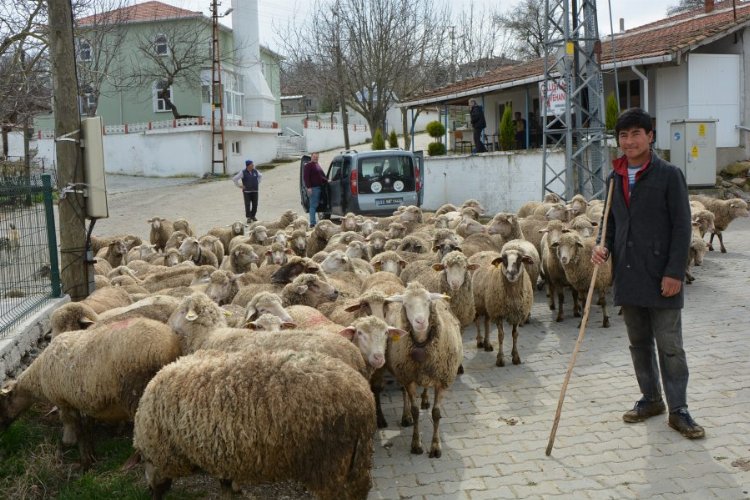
xmin=47 ymin=0 xmax=88 ymax=300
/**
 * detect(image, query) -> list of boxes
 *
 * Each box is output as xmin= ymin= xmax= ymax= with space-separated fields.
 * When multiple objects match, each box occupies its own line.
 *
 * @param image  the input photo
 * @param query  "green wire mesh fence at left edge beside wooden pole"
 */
xmin=0 ymin=174 xmax=61 ymax=338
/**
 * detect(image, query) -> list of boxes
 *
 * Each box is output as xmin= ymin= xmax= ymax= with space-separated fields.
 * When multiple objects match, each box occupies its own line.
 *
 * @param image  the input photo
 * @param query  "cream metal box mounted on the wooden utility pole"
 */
xmin=81 ymin=116 xmax=109 ymax=219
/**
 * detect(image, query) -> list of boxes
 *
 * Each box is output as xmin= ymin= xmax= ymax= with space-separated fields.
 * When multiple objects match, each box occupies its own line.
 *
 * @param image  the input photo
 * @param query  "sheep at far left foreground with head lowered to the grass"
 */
xmin=0 ymin=319 xmax=181 ymax=468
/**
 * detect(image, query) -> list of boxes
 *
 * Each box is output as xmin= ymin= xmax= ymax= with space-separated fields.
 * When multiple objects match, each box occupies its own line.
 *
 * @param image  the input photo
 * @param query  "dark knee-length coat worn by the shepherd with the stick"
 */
xmin=605 ymin=152 xmax=692 ymax=309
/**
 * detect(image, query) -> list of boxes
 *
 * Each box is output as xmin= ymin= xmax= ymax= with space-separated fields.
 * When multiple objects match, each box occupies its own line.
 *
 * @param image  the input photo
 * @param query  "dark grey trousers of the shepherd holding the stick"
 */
xmin=622 ymin=306 xmax=688 ymax=413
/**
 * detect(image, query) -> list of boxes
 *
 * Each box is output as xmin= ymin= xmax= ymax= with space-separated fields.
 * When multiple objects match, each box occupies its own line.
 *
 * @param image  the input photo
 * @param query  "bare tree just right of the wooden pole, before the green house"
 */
xmin=74 ymin=0 xmax=130 ymax=116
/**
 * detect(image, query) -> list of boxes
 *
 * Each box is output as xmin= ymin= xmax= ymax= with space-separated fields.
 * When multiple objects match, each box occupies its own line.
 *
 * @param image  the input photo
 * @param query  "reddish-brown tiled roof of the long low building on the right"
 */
xmin=403 ymin=0 xmax=750 ymax=104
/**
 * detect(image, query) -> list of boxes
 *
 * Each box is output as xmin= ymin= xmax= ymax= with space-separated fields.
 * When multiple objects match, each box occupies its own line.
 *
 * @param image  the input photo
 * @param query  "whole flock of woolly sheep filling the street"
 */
xmin=0 ymin=189 xmax=748 ymax=499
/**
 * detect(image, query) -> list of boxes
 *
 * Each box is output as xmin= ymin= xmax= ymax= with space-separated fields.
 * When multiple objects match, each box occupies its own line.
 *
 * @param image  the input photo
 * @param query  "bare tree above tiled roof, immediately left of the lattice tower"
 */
xmin=495 ymin=0 xmax=546 ymax=60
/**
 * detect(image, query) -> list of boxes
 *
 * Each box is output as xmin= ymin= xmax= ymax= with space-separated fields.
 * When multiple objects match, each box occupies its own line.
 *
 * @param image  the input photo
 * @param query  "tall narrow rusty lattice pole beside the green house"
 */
xmin=211 ymin=0 xmax=227 ymax=175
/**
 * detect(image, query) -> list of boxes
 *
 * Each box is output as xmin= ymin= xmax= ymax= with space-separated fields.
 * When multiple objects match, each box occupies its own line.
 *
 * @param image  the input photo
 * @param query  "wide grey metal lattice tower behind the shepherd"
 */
xmin=542 ymin=0 xmax=607 ymax=200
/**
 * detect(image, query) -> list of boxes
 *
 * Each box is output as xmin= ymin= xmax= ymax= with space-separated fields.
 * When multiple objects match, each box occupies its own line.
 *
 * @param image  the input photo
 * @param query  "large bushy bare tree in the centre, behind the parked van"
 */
xmin=282 ymin=0 xmax=447 ymax=144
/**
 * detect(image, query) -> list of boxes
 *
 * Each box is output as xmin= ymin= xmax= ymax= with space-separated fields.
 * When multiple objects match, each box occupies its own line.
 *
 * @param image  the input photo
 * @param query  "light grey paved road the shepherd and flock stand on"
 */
xmin=89 ymin=138 xmax=750 ymax=500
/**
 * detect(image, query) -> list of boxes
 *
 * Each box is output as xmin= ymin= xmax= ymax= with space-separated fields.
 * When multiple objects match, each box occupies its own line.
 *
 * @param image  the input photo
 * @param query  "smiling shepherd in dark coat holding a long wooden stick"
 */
xmin=591 ymin=108 xmax=705 ymax=439
